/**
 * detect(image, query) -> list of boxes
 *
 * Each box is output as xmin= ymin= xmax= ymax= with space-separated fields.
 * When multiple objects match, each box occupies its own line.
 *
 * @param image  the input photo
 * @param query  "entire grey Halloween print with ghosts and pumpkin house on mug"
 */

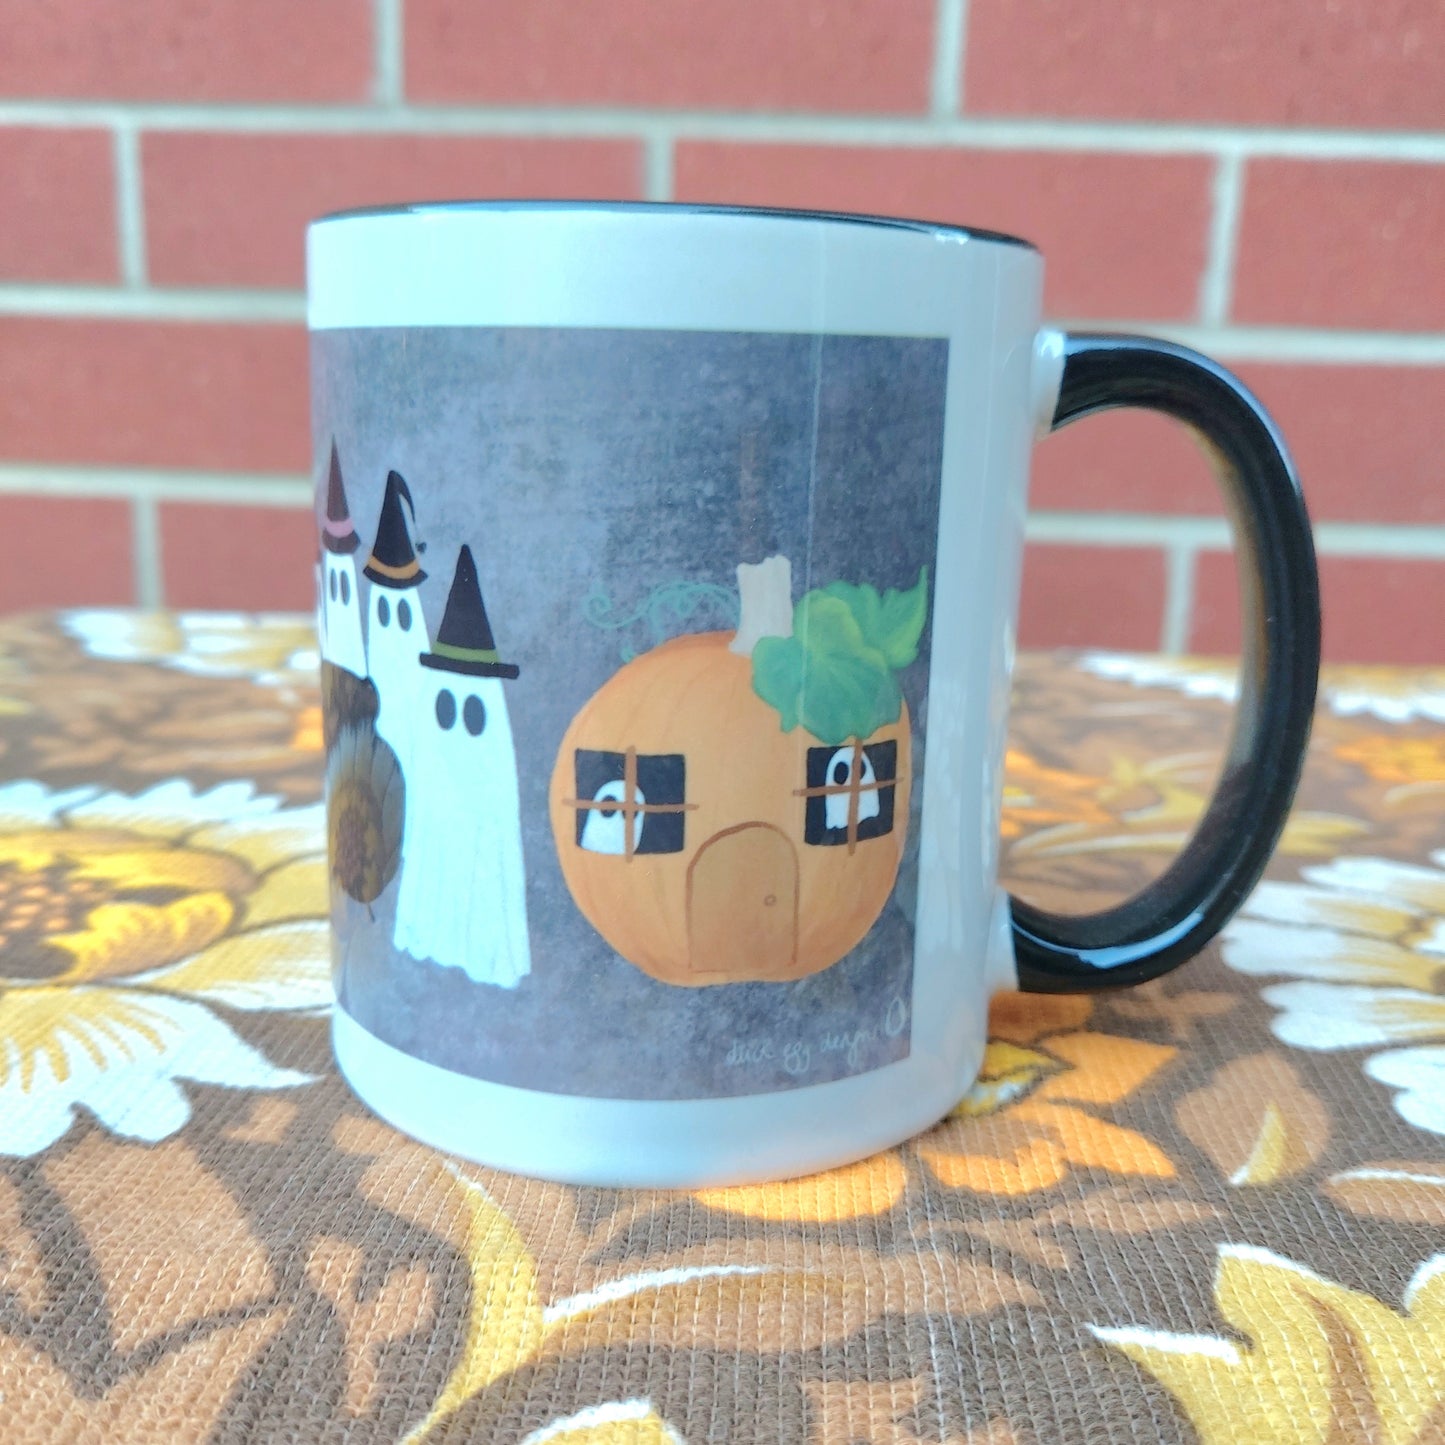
xmin=311 ymin=325 xmax=947 ymax=1100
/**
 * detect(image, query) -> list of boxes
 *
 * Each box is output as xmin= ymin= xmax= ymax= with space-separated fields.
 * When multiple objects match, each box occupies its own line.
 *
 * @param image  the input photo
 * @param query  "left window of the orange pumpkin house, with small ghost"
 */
xmin=571 ymin=747 xmax=688 ymax=857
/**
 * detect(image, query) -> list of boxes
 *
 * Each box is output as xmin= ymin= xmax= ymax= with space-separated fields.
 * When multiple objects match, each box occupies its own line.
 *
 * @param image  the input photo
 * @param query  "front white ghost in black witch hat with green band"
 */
xmin=393 ymin=546 xmax=532 ymax=988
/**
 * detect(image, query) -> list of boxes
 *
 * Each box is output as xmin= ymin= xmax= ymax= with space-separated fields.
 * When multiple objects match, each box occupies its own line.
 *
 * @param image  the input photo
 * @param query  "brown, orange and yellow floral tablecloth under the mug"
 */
xmin=0 ymin=613 xmax=1445 ymax=1445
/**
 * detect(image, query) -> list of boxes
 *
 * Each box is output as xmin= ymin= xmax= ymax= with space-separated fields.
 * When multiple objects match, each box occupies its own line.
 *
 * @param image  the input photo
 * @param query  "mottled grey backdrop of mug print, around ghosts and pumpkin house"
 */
xmin=312 ymin=328 xmax=948 ymax=1098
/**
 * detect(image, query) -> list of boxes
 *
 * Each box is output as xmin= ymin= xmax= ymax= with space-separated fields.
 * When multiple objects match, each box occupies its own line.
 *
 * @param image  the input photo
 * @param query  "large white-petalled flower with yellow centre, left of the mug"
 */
xmin=0 ymin=779 xmax=331 ymax=1156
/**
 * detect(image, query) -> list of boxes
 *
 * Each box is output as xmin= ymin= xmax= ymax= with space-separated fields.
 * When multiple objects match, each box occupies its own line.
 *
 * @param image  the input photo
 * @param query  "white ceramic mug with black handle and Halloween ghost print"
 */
xmin=308 ymin=202 xmax=1319 ymax=1185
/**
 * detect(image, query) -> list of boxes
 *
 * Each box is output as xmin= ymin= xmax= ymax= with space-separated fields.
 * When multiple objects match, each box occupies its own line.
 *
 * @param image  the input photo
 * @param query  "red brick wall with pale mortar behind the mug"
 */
xmin=0 ymin=0 xmax=1445 ymax=662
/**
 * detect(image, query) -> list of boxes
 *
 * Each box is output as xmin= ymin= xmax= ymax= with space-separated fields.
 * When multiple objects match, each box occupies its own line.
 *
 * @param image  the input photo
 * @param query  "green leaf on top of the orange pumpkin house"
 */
xmin=753 ymin=584 xmax=916 ymax=746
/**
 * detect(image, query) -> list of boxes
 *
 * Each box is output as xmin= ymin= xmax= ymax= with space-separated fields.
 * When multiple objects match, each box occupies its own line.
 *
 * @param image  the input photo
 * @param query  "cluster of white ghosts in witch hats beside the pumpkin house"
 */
xmin=319 ymin=445 xmax=532 ymax=988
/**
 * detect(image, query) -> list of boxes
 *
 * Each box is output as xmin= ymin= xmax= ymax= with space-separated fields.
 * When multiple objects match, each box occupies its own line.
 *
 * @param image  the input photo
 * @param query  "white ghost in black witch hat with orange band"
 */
xmin=364 ymin=471 xmax=431 ymax=786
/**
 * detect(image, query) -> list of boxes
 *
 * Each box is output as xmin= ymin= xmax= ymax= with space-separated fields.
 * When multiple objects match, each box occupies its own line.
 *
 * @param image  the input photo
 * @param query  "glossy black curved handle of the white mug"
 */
xmin=1009 ymin=334 xmax=1319 ymax=993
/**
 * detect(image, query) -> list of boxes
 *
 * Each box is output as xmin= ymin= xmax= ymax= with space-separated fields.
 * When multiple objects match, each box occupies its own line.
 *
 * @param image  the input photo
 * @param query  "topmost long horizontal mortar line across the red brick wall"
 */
xmin=8 ymin=100 xmax=1445 ymax=165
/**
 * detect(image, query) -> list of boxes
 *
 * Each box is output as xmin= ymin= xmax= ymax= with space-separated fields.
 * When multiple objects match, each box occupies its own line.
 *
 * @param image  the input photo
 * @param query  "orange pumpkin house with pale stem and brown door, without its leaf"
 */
xmin=549 ymin=558 xmax=922 ymax=985
